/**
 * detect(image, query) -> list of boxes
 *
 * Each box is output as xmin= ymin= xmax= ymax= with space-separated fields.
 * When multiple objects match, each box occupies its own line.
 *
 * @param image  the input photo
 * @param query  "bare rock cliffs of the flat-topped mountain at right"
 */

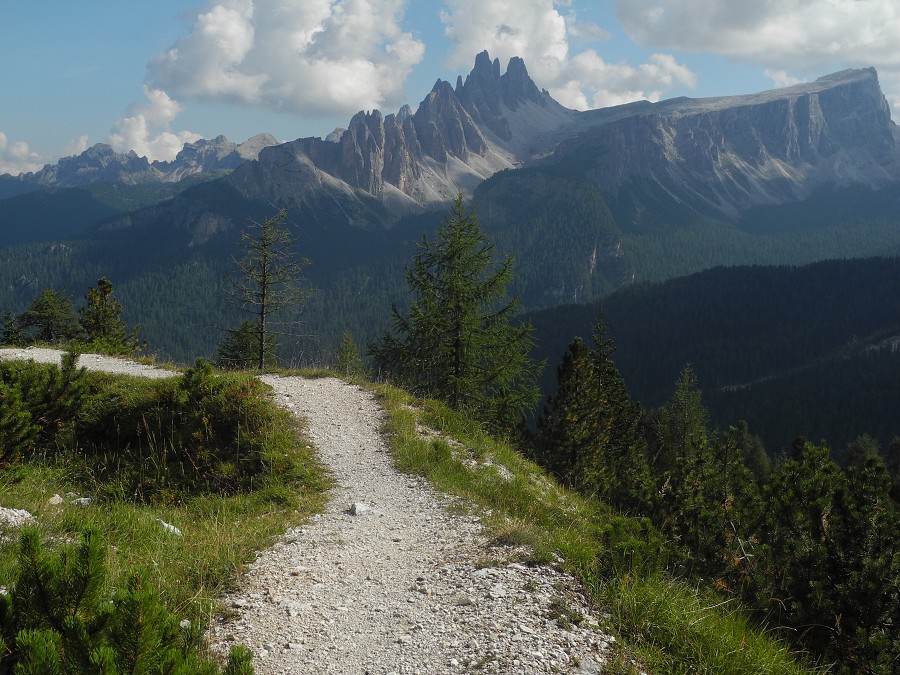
xmin=549 ymin=69 xmax=900 ymax=216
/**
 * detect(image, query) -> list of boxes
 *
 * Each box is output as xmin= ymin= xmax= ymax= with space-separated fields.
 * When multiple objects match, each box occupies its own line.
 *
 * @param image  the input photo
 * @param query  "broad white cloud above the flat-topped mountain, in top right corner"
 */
xmin=616 ymin=0 xmax=900 ymax=110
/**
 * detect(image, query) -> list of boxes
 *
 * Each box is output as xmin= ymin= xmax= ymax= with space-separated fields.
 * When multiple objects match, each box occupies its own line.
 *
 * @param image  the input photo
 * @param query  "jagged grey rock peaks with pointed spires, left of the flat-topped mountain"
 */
xmin=229 ymin=52 xmax=576 ymax=215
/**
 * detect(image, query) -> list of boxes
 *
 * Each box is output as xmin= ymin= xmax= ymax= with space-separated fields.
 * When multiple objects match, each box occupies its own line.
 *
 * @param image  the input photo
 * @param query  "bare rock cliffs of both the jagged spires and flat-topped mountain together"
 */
xmin=232 ymin=57 xmax=900 ymax=224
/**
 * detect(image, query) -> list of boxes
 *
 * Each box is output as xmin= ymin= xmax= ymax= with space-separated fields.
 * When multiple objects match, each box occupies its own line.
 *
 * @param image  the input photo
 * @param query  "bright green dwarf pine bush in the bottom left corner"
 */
xmin=0 ymin=529 xmax=253 ymax=675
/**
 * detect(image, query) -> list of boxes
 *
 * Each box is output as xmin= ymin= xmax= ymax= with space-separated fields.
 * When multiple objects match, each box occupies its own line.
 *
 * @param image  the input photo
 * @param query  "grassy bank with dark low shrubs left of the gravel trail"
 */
xmin=0 ymin=372 xmax=328 ymax=623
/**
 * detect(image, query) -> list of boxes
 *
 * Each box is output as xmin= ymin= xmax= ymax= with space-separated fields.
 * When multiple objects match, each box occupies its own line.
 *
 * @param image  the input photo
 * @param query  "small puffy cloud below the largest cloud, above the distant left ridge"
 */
xmin=107 ymin=85 xmax=201 ymax=161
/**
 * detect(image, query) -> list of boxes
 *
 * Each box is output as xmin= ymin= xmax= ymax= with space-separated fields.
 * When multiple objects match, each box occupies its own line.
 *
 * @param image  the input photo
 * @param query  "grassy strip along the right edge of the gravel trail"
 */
xmin=376 ymin=385 xmax=821 ymax=674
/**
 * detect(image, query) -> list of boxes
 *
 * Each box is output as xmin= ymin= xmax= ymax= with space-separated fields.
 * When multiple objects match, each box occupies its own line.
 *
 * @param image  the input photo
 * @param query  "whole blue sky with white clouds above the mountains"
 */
xmin=0 ymin=0 xmax=900 ymax=174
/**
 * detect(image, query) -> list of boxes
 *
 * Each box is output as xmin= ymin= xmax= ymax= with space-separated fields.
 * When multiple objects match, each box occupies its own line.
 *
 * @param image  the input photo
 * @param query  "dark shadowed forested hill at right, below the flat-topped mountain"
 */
xmin=530 ymin=258 xmax=900 ymax=454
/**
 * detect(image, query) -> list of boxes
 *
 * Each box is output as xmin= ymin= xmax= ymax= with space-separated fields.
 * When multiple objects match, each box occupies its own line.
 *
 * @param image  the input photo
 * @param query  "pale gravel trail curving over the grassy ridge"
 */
xmin=0 ymin=350 xmax=612 ymax=675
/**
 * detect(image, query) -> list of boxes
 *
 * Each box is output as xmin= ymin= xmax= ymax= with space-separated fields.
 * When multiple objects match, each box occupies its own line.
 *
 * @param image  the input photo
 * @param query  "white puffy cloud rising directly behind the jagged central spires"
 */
xmin=441 ymin=0 xmax=696 ymax=109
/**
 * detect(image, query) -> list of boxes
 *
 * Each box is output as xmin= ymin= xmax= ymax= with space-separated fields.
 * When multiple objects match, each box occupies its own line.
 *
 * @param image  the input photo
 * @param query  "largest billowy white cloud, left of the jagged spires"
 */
xmin=146 ymin=0 xmax=425 ymax=116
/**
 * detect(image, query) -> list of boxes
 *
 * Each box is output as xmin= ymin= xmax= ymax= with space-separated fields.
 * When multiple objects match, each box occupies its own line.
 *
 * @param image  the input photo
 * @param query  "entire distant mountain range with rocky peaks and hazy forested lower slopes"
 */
xmin=0 ymin=52 xmax=900 ymax=368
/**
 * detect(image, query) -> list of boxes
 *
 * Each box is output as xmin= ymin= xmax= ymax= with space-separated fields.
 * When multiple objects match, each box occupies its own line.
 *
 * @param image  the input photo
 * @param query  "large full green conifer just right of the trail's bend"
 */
xmin=371 ymin=195 xmax=540 ymax=428
